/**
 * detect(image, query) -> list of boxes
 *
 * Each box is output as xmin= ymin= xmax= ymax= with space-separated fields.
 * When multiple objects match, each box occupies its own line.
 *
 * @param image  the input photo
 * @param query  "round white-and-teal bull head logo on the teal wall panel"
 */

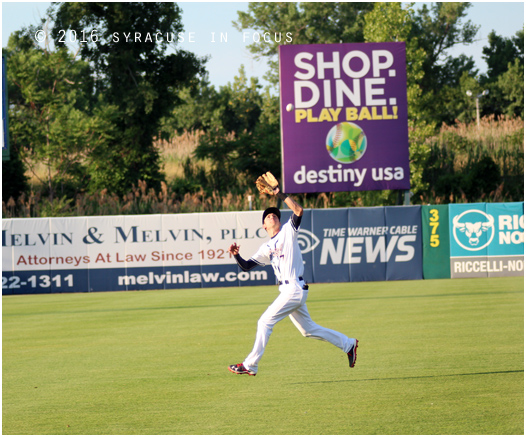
xmin=453 ymin=209 xmax=495 ymax=251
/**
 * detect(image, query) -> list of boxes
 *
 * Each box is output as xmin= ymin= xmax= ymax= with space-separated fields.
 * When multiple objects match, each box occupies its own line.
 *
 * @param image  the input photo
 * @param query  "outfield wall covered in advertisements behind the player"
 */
xmin=2 ymin=202 xmax=524 ymax=294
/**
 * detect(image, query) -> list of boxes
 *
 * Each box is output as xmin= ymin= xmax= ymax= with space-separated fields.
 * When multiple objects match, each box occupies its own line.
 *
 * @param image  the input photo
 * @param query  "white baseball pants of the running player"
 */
xmin=243 ymin=281 xmax=353 ymax=372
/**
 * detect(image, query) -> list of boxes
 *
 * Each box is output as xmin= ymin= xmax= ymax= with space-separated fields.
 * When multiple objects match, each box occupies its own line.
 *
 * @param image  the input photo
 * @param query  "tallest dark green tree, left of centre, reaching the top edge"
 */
xmin=49 ymin=2 xmax=204 ymax=194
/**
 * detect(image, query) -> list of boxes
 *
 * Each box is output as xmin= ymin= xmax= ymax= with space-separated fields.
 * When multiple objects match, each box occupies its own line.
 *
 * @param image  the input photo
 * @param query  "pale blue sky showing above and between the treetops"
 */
xmin=2 ymin=1 xmax=524 ymax=88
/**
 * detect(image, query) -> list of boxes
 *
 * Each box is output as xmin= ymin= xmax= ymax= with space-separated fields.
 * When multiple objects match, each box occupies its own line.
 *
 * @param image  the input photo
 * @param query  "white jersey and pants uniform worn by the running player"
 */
xmin=236 ymin=214 xmax=355 ymax=372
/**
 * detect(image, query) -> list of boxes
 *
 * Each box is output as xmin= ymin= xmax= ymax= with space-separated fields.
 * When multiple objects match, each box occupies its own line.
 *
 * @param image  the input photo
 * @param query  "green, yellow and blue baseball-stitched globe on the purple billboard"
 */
xmin=326 ymin=121 xmax=367 ymax=164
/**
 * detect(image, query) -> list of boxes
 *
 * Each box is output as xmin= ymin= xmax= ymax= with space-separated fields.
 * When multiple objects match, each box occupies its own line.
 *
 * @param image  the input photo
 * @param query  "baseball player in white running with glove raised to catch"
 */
xmin=228 ymin=172 xmax=358 ymax=376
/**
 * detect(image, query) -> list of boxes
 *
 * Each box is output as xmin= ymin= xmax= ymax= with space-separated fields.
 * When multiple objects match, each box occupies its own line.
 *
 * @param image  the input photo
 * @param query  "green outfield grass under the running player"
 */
xmin=2 ymin=278 xmax=524 ymax=435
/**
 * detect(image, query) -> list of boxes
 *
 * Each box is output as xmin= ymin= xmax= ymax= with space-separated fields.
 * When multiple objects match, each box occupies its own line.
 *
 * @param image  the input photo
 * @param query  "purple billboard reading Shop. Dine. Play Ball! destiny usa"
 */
xmin=279 ymin=42 xmax=410 ymax=193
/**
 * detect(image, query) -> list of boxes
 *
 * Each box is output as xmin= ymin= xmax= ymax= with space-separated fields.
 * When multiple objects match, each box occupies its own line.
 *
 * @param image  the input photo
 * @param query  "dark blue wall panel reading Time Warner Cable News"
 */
xmin=313 ymin=206 xmax=422 ymax=282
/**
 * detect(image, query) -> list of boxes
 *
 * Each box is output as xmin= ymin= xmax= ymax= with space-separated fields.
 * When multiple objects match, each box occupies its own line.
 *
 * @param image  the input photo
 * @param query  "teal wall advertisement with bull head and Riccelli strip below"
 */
xmin=449 ymin=202 xmax=524 ymax=278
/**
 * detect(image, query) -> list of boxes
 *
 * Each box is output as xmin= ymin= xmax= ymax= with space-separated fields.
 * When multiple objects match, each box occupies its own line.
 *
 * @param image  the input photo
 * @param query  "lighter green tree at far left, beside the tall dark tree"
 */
xmin=4 ymin=28 xmax=101 ymax=201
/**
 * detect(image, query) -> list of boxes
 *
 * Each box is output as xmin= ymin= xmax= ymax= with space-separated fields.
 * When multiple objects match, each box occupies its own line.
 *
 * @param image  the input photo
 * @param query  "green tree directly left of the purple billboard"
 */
xmin=167 ymin=66 xmax=281 ymax=198
